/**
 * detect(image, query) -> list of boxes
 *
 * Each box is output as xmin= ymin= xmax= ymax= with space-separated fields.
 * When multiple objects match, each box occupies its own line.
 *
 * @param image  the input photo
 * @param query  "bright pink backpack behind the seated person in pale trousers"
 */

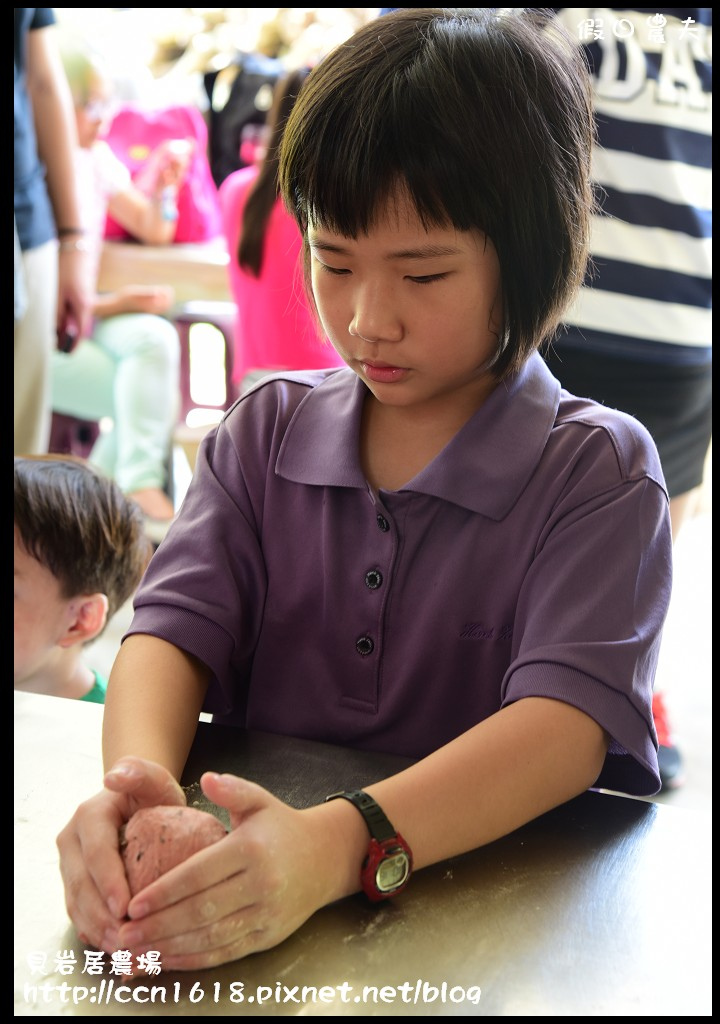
xmin=103 ymin=103 xmax=222 ymax=243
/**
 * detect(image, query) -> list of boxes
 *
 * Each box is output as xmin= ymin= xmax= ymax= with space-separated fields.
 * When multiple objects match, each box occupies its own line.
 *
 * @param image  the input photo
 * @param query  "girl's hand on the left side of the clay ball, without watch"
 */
xmin=57 ymin=758 xmax=185 ymax=952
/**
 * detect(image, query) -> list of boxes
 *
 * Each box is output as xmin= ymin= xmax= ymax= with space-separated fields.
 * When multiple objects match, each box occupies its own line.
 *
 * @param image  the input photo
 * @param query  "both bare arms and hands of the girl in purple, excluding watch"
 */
xmin=60 ymin=636 xmax=607 ymax=970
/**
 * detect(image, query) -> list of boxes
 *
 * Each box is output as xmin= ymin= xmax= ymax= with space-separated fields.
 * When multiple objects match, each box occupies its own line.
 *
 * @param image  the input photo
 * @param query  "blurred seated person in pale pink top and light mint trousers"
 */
xmin=52 ymin=35 xmax=188 ymax=541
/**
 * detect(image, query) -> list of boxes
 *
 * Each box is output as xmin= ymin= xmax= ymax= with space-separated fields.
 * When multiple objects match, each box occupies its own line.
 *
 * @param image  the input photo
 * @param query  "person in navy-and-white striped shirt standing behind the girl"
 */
xmin=545 ymin=7 xmax=713 ymax=788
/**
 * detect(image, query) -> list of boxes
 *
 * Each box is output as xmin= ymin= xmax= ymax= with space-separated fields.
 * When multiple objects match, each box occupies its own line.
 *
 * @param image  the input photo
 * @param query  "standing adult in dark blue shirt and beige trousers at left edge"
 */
xmin=13 ymin=7 xmax=91 ymax=454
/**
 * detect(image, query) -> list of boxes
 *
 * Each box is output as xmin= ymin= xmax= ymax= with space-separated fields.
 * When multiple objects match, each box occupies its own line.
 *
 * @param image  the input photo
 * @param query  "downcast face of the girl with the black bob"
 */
xmin=308 ymin=196 xmax=503 ymax=415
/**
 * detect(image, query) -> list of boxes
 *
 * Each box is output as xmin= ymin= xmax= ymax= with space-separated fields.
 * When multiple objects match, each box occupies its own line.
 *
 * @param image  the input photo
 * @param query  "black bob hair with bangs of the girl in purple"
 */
xmin=280 ymin=7 xmax=594 ymax=378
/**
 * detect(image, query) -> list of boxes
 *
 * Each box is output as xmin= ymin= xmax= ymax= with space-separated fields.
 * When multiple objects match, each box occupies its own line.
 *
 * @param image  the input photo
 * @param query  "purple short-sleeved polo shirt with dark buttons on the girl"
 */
xmin=128 ymin=354 xmax=672 ymax=795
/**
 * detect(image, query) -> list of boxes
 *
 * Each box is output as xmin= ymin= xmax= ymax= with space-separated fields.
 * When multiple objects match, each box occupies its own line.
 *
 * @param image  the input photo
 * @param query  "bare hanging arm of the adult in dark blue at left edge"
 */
xmin=27 ymin=26 xmax=92 ymax=337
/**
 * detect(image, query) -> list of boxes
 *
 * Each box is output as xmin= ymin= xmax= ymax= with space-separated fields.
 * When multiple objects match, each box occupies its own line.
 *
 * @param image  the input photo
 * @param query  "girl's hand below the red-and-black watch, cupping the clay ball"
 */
xmin=117 ymin=772 xmax=343 ymax=971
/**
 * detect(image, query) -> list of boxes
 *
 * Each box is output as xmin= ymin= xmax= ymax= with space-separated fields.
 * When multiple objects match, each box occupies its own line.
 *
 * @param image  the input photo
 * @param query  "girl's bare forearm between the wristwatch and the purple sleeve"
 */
xmin=368 ymin=697 xmax=607 ymax=867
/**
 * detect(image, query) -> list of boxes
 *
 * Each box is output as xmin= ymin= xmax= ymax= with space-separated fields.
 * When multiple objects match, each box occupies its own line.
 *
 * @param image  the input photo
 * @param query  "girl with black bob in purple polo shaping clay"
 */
xmin=58 ymin=8 xmax=671 ymax=970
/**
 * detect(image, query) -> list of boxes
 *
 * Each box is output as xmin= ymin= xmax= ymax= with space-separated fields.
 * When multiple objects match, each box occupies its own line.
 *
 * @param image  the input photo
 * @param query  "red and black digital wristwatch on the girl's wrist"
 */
xmin=325 ymin=790 xmax=413 ymax=903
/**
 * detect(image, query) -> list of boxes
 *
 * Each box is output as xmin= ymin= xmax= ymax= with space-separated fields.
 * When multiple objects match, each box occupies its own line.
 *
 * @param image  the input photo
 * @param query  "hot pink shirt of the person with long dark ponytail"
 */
xmin=219 ymin=167 xmax=344 ymax=384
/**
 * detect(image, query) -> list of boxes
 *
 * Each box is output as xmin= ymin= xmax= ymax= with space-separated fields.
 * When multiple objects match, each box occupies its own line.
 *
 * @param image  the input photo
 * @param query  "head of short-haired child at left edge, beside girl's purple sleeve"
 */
xmin=14 ymin=455 xmax=153 ymax=688
